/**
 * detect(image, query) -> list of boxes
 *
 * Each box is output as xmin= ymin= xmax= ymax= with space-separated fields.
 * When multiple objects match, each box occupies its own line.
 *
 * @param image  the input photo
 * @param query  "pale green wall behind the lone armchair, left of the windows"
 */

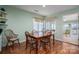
xmin=0 ymin=6 xmax=42 ymax=46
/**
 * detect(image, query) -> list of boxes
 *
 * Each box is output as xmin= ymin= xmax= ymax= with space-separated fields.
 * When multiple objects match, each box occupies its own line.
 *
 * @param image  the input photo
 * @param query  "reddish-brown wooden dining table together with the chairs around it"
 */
xmin=25 ymin=31 xmax=55 ymax=54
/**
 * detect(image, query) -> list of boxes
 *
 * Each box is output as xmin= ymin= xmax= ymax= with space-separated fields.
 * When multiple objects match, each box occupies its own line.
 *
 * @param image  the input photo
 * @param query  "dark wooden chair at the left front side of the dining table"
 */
xmin=25 ymin=31 xmax=36 ymax=53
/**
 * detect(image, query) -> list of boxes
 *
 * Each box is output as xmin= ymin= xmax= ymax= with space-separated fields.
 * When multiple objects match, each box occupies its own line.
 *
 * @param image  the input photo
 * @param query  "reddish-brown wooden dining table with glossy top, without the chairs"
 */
xmin=29 ymin=34 xmax=55 ymax=54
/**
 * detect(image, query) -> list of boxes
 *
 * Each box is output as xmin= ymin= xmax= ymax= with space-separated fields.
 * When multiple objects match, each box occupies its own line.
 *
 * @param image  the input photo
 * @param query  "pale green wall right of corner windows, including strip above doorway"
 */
xmin=48 ymin=7 xmax=79 ymax=45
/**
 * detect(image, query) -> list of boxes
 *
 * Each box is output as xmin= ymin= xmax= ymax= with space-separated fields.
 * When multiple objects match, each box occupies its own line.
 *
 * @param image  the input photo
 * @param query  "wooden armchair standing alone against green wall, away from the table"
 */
xmin=4 ymin=29 xmax=20 ymax=47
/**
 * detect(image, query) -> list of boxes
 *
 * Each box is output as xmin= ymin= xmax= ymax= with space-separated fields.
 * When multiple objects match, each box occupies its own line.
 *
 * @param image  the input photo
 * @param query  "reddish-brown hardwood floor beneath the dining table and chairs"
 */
xmin=2 ymin=41 xmax=79 ymax=54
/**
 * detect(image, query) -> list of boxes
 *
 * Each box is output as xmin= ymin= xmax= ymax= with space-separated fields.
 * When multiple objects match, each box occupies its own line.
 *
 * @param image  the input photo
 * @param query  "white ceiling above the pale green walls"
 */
xmin=14 ymin=5 xmax=77 ymax=16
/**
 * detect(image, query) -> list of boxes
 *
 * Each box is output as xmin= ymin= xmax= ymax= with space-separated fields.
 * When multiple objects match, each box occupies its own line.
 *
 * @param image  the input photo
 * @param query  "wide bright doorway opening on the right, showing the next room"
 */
xmin=63 ymin=13 xmax=79 ymax=45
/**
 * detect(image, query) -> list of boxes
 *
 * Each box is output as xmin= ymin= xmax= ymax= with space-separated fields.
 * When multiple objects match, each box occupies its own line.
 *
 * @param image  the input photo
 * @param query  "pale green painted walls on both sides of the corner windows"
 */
xmin=0 ymin=6 xmax=79 ymax=51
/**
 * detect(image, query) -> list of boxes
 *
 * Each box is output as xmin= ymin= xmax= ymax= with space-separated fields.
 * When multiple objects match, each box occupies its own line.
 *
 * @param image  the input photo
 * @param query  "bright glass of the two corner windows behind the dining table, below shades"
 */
xmin=33 ymin=19 xmax=56 ymax=33
